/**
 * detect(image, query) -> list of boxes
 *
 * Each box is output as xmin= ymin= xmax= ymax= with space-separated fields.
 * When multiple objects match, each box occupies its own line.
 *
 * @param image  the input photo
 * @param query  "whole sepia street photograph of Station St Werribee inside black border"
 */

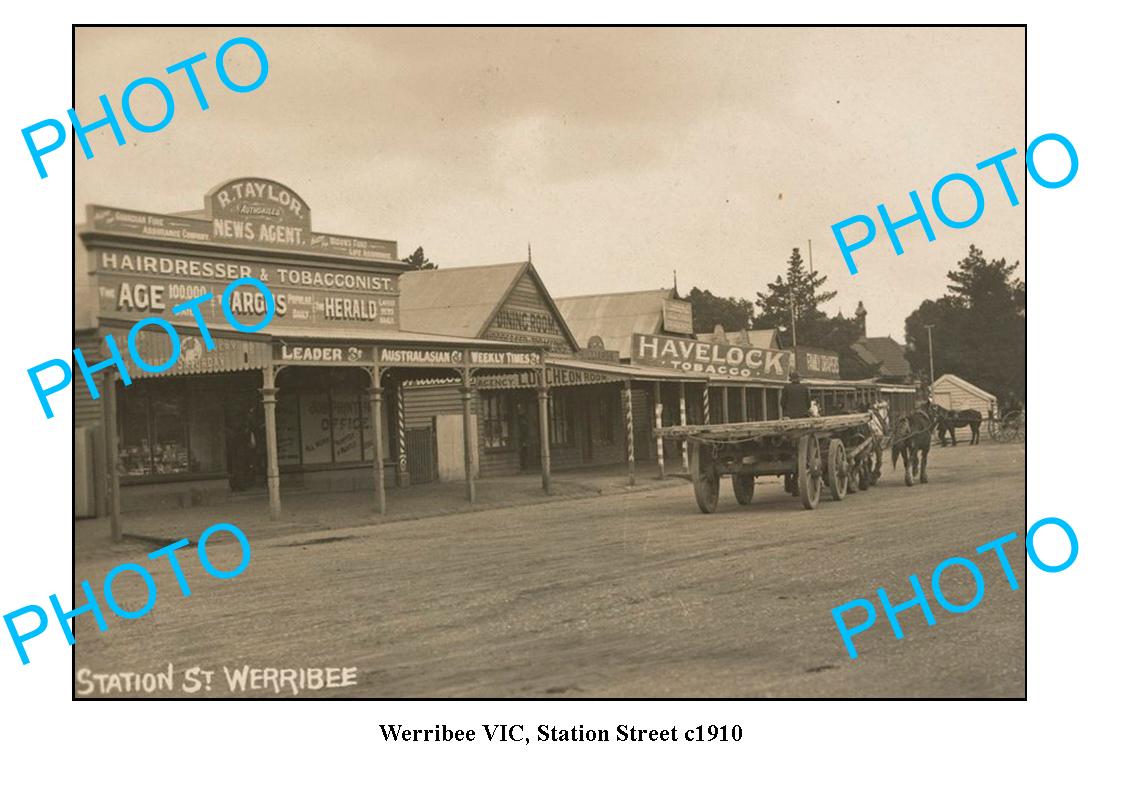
xmin=70 ymin=25 xmax=1028 ymax=696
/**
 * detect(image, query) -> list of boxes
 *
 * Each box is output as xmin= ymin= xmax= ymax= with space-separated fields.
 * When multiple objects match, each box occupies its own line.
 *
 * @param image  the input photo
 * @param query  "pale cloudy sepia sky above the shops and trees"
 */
xmin=74 ymin=23 xmax=1026 ymax=340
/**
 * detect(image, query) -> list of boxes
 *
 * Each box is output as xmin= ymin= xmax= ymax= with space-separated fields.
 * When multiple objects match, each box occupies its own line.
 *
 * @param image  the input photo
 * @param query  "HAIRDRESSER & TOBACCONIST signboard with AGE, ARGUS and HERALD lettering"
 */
xmin=90 ymin=246 xmax=398 ymax=330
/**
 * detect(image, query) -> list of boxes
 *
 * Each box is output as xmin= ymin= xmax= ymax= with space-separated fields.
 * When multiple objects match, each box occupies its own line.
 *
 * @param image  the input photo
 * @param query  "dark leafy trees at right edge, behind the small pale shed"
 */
xmin=905 ymin=245 xmax=1025 ymax=401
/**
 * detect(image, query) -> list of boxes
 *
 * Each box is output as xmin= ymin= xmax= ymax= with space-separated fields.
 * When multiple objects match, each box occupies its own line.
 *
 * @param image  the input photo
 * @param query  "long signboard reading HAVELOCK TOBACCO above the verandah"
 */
xmin=632 ymin=335 xmax=794 ymax=378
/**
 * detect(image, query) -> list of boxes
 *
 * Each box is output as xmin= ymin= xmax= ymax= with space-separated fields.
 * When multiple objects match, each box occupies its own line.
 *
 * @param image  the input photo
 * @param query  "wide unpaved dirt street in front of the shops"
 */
xmin=74 ymin=443 xmax=1025 ymax=697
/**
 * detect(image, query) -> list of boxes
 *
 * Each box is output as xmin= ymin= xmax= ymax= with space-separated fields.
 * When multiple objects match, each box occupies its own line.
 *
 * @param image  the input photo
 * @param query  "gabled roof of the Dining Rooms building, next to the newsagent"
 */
xmin=398 ymin=262 xmax=579 ymax=348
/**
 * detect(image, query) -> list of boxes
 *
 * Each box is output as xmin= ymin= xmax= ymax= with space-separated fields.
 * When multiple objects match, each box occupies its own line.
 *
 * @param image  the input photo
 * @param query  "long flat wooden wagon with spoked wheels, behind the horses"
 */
xmin=656 ymin=414 xmax=877 ymax=514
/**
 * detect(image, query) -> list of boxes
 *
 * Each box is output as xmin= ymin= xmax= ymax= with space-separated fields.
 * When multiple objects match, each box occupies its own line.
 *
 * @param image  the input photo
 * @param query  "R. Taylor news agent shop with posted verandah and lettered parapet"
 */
xmin=75 ymin=179 xmax=545 ymax=527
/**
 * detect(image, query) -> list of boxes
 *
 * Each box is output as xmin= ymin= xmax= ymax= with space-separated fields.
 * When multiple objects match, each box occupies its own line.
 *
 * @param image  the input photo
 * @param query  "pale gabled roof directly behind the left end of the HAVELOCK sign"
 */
xmin=557 ymin=287 xmax=676 ymax=356
